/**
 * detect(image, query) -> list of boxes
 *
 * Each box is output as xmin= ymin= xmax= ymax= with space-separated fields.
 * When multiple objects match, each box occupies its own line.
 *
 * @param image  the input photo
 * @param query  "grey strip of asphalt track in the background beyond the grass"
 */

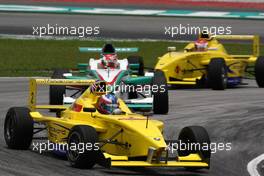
xmin=0 ymin=13 xmax=264 ymax=41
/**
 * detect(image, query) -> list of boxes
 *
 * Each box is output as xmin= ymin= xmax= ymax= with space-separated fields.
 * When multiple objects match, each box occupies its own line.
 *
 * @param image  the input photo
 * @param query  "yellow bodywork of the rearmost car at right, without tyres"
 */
xmin=155 ymin=35 xmax=259 ymax=85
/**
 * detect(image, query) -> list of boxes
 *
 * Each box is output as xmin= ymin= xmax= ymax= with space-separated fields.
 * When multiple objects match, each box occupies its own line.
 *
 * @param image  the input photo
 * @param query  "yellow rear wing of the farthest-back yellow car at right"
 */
xmin=215 ymin=35 xmax=260 ymax=57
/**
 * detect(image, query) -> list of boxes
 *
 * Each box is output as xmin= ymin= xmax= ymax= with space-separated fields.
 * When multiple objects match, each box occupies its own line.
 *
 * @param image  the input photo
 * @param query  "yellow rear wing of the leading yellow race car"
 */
xmin=28 ymin=78 xmax=95 ymax=111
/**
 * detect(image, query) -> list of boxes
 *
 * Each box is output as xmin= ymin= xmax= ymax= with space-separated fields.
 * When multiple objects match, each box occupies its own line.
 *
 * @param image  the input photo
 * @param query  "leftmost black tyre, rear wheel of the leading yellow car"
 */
xmin=4 ymin=107 xmax=34 ymax=150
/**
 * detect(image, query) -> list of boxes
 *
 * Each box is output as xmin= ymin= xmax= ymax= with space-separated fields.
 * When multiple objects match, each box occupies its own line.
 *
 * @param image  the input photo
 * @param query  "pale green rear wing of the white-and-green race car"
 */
xmin=79 ymin=47 xmax=139 ymax=53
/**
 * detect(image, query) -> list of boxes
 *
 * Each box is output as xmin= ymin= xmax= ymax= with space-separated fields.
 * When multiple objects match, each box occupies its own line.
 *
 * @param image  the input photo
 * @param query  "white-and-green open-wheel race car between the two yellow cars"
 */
xmin=50 ymin=44 xmax=168 ymax=114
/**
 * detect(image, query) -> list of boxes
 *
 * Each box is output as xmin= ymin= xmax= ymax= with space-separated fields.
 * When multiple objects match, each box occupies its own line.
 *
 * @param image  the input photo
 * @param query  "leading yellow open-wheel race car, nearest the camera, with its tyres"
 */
xmin=4 ymin=79 xmax=211 ymax=169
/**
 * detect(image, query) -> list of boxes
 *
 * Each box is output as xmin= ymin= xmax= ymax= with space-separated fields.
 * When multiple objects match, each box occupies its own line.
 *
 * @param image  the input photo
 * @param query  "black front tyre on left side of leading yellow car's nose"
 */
xmin=67 ymin=125 xmax=100 ymax=169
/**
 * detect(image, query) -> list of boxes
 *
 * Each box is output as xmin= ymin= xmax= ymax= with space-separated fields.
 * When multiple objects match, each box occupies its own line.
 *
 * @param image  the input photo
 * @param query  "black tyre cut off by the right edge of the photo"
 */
xmin=255 ymin=56 xmax=264 ymax=88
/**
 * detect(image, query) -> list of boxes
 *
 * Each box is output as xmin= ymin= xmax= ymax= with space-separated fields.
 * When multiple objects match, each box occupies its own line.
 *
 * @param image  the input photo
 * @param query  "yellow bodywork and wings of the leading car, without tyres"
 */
xmin=29 ymin=79 xmax=209 ymax=168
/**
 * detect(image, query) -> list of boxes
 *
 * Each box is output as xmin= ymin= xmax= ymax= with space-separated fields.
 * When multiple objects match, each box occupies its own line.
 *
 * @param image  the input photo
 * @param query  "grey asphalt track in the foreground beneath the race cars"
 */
xmin=0 ymin=78 xmax=264 ymax=176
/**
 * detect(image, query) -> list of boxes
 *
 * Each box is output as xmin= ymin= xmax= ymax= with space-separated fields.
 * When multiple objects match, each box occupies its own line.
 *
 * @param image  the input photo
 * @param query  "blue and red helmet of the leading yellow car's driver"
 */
xmin=96 ymin=93 xmax=119 ymax=114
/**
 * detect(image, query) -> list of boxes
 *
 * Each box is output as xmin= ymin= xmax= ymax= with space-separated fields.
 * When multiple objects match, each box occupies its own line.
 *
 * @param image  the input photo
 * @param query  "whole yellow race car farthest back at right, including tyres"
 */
xmin=155 ymin=33 xmax=264 ymax=90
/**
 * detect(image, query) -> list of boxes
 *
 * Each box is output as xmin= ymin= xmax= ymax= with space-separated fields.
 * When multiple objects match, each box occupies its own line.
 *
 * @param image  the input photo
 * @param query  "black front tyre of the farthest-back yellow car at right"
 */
xmin=207 ymin=58 xmax=227 ymax=90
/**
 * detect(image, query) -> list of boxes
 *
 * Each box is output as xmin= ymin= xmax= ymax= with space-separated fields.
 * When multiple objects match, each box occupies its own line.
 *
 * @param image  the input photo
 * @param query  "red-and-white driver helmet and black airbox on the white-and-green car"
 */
xmin=102 ymin=44 xmax=118 ymax=68
